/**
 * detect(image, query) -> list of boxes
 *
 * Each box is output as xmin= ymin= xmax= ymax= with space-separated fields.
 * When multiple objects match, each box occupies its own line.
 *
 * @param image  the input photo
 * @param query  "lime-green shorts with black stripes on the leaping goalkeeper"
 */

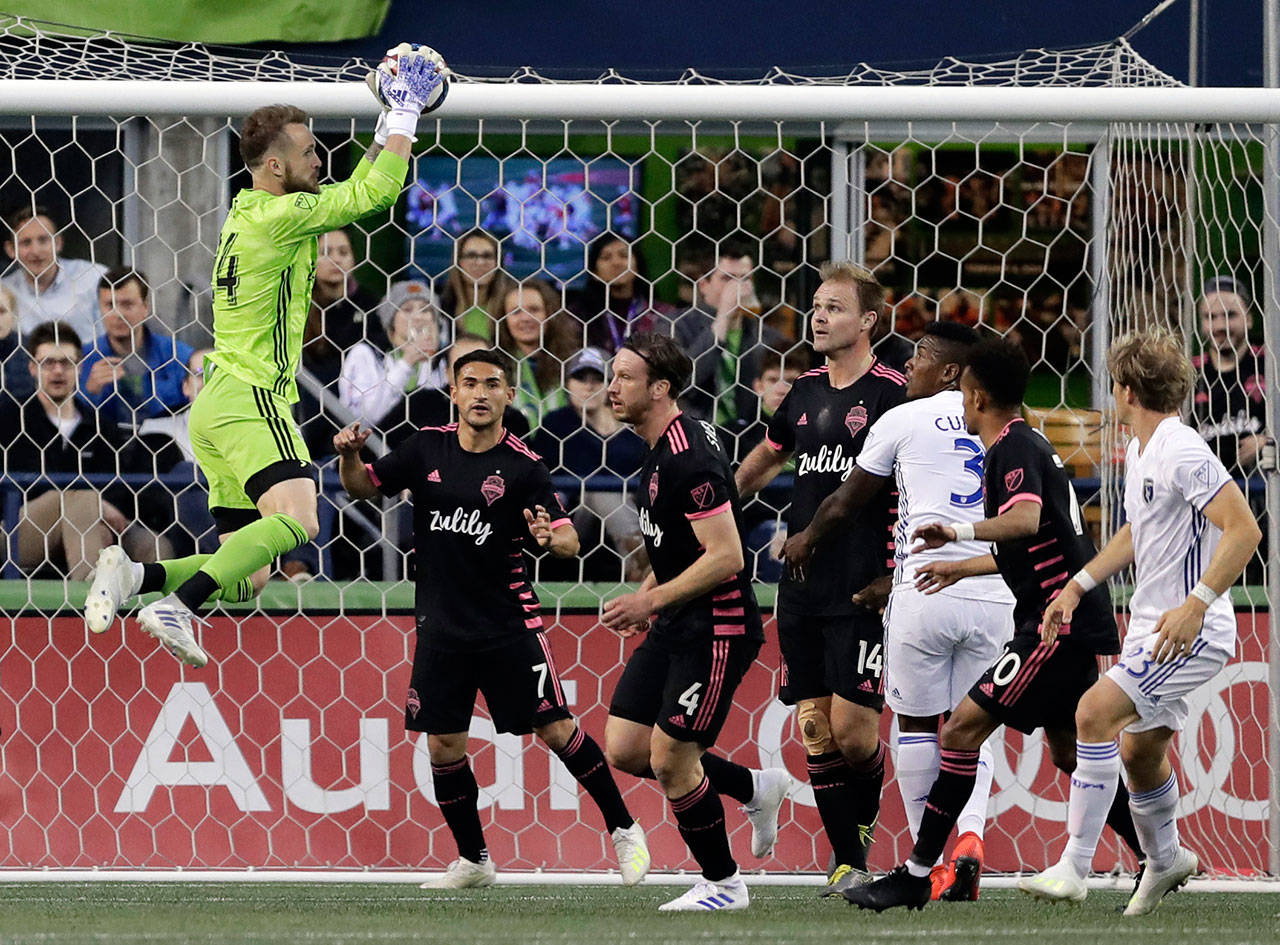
xmin=191 ymin=365 xmax=316 ymax=531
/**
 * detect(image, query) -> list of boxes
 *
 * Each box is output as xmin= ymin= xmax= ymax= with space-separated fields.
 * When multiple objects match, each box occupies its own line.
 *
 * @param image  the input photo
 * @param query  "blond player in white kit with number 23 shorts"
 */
xmin=1019 ymin=333 xmax=1262 ymax=916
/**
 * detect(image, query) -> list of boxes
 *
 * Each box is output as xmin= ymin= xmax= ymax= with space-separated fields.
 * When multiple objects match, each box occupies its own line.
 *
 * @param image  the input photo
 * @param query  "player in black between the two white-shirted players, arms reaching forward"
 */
xmin=845 ymin=339 xmax=1142 ymax=912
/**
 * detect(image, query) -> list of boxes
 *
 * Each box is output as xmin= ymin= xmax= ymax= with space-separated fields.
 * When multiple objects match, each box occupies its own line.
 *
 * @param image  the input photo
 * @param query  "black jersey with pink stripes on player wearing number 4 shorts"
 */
xmin=636 ymin=414 xmax=764 ymax=640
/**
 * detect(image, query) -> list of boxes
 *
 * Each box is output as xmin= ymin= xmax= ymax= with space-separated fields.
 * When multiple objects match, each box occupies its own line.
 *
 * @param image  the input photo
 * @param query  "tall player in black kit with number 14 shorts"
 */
xmin=737 ymin=263 xmax=906 ymax=895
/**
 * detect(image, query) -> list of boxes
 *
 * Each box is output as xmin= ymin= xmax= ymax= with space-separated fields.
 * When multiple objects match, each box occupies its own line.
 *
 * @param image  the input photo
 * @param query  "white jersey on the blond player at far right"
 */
xmin=1124 ymin=416 xmax=1235 ymax=653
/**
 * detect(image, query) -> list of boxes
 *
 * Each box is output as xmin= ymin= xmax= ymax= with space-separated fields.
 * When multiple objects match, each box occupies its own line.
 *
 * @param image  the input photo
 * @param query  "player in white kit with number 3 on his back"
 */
xmin=783 ymin=321 xmax=1014 ymax=900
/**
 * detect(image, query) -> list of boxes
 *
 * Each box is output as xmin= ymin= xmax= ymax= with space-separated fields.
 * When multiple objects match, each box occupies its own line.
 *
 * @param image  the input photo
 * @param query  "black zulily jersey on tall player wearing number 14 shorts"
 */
xmin=767 ymin=359 xmax=906 ymax=617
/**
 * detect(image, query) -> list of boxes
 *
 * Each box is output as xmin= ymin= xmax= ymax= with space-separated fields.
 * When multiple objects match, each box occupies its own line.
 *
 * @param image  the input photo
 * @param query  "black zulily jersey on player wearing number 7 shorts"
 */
xmin=369 ymin=424 xmax=570 ymax=649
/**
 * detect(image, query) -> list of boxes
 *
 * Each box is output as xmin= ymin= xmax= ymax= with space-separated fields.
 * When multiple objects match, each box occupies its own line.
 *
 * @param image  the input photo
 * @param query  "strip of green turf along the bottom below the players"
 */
xmin=0 ymin=882 xmax=1280 ymax=945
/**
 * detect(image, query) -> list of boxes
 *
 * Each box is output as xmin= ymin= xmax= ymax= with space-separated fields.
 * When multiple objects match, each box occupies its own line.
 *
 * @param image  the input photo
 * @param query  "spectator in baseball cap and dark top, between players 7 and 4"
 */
xmin=531 ymin=348 xmax=649 ymax=580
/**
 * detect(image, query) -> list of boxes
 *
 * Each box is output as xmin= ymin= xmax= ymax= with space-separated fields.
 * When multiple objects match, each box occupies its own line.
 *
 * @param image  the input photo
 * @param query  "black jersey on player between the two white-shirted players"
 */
xmin=983 ymin=419 xmax=1120 ymax=653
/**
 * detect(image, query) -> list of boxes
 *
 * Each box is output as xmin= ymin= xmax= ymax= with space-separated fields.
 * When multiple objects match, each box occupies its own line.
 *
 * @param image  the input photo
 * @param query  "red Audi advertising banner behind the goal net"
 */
xmin=0 ymin=613 xmax=1268 ymax=873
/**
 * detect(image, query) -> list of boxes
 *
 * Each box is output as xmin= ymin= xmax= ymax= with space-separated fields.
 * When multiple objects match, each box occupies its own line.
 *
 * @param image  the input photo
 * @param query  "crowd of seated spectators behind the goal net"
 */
xmin=0 ymin=207 xmax=1266 ymax=580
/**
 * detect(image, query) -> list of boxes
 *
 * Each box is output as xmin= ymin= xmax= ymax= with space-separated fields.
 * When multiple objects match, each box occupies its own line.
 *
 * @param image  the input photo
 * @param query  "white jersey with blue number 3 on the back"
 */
xmin=856 ymin=391 xmax=1014 ymax=604
